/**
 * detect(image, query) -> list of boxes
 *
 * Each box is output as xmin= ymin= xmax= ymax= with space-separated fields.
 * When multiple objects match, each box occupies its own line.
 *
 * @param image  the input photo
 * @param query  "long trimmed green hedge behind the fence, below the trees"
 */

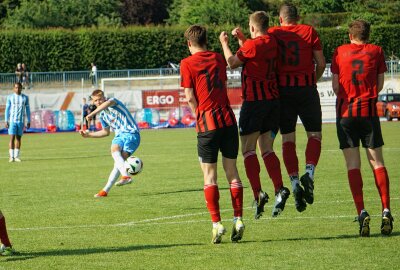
xmin=0 ymin=25 xmax=400 ymax=73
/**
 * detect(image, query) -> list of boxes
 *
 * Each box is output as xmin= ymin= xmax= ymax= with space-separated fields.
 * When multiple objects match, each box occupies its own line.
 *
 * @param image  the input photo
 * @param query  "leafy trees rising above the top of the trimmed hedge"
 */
xmin=0 ymin=0 xmax=400 ymax=29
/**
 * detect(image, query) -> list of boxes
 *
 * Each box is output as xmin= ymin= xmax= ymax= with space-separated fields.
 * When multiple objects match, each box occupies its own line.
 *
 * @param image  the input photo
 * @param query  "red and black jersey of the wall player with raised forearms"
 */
xmin=236 ymin=35 xmax=279 ymax=101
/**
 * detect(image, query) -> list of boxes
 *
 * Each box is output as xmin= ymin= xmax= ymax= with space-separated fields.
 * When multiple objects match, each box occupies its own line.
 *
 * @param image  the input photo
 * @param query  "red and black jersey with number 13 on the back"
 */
xmin=268 ymin=24 xmax=322 ymax=86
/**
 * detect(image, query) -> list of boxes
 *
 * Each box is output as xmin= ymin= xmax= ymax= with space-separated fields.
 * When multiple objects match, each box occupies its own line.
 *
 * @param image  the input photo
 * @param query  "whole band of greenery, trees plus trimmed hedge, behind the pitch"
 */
xmin=0 ymin=0 xmax=400 ymax=72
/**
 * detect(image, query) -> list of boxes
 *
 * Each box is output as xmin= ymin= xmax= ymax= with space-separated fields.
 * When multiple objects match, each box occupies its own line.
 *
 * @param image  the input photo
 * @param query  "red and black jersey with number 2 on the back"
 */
xmin=331 ymin=44 xmax=387 ymax=117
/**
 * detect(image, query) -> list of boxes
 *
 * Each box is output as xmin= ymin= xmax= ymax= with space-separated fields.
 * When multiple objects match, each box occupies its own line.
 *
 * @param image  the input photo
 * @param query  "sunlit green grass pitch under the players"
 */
xmin=0 ymin=121 xmax=400 ymax=270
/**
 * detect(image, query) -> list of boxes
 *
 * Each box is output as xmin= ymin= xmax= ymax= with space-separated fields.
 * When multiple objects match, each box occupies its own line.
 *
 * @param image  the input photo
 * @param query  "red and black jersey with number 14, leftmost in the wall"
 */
xmin=180 ymin=51 xmax=236 ymax=132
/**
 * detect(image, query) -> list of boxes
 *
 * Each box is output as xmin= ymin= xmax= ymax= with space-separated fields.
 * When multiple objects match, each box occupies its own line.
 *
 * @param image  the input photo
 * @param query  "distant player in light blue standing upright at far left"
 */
xmin=5 ymin=83 xmax=31 ymax=162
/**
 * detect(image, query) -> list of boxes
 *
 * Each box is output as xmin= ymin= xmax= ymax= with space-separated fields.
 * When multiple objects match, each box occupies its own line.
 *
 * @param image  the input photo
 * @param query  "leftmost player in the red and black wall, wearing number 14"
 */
xmin=180 ymin=25 xmax=244 ymax=244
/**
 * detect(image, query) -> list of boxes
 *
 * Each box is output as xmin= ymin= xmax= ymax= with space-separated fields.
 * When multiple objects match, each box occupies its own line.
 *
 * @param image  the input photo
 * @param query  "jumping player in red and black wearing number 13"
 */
xmin=268 ymin=4 xmax=326 ymax=212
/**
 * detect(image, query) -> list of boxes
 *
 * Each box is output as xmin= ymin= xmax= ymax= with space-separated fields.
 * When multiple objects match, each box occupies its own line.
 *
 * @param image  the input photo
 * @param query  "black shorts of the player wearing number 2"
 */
xmin=336 ymin=117 xmax=384 ymax=149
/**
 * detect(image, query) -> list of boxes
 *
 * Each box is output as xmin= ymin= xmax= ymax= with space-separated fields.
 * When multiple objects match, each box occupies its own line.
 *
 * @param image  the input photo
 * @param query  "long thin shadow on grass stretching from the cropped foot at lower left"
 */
xmin=4 ymin=243 xmax=203 ymax=262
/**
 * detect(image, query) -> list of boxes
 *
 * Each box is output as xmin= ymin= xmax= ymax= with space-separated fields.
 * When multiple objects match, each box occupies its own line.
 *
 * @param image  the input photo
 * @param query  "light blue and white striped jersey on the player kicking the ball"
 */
xmin=100 ymin=98 xmax=139 ymax=135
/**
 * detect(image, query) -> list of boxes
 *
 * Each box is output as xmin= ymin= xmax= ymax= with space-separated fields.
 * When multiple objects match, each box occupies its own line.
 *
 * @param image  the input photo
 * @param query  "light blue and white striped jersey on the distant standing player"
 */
xmin=5 ymin=93 xmax=31 ymax=123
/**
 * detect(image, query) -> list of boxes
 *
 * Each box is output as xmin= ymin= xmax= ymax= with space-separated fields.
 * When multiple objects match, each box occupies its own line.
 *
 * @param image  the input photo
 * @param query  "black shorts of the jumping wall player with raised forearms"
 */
xmin=239 ymin=99 xmax=280 ymax=136
